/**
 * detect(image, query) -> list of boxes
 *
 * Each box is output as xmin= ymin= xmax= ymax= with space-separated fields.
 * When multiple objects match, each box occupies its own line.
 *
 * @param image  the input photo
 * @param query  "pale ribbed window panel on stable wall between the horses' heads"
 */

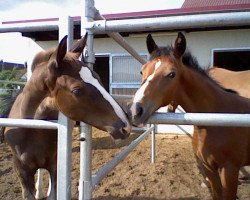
xmin=112 ymin=55 xmax=147 ymax=83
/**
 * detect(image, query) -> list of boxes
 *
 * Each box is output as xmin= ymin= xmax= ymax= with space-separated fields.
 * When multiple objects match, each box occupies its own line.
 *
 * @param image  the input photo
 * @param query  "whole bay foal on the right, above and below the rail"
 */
xmin=128 ymin=33 xmax=250 ymax=200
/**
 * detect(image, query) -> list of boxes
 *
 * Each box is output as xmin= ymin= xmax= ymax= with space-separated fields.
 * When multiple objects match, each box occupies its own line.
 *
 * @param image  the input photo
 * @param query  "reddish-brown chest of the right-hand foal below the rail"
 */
xmin=193 ymin=127 xmax=250 ymax=165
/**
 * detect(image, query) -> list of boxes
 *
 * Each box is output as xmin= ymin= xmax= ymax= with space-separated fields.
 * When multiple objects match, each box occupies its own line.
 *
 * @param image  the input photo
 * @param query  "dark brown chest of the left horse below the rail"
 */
xmin=6 ymin=128 xmax=57 ymax=168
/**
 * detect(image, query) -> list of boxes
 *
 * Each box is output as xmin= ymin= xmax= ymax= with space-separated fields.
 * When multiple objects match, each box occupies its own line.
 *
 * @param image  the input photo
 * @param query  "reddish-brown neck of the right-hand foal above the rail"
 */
xmin=177 ymin=69 xmax=239 ymax=112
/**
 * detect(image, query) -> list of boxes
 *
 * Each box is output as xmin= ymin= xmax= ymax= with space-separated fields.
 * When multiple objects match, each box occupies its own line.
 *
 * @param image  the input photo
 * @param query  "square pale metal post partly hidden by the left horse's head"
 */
xmin=57 ymin=16 xmax=73 ymax=200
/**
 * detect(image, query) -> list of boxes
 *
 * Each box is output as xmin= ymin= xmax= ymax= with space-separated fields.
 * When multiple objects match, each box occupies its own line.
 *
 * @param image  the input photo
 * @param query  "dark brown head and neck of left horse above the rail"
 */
xmin=4 ymin=34 xmax=131 ymax=139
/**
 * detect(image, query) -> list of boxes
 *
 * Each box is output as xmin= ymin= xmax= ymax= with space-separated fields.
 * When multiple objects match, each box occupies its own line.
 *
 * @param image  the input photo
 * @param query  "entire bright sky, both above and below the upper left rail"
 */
xmin=0 ymin=0 xmax=184 ymax=63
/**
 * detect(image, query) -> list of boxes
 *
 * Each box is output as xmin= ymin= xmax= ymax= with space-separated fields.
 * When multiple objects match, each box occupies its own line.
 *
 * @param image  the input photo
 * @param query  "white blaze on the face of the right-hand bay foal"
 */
xmin=131 ymin=60 xmax=161 ymax=117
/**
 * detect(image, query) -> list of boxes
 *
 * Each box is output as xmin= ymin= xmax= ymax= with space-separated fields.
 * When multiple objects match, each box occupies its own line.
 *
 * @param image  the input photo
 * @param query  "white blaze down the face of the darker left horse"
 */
xmin=79 ymin=67 xmax=129 ymax=126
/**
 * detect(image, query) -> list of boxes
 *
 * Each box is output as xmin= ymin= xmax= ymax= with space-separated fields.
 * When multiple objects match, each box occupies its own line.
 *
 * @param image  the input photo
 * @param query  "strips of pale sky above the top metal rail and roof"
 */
xmin=0 ymin=0 xmax=184 ymax=21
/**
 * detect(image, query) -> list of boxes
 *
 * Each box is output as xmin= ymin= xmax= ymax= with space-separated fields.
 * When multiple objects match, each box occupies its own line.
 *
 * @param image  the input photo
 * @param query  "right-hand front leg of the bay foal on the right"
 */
xmin=220 ymin=164 xmax=240 ymax=200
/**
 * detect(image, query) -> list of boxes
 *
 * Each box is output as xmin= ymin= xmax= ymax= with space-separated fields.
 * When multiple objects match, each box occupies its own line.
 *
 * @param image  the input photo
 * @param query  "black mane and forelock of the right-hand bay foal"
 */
xmin=150 ymin=46 xmax=238 ymax=94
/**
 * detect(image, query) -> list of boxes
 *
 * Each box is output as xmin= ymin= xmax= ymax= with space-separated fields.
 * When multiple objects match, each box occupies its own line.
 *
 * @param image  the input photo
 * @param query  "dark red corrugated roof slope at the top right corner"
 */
xmin=182 ymin=0 xmax=250 ymax=8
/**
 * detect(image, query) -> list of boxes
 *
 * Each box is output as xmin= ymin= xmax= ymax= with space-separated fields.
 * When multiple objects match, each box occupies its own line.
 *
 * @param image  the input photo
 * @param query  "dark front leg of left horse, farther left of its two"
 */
xmin=14 ymin=158 xmax=35 ymax=200
